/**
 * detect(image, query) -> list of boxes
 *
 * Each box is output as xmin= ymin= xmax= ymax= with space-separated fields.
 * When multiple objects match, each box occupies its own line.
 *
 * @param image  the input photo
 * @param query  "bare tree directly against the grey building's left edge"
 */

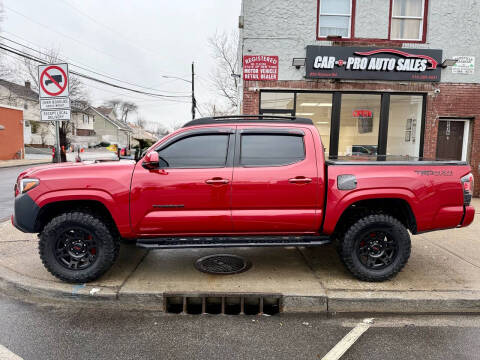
xmin=208 ymin=32 xmax=239 ymax=113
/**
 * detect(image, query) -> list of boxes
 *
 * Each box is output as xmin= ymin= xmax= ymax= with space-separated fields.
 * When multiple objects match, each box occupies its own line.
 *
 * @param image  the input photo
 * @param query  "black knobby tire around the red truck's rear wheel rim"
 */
xmin=339 ymin=214 xmax=411 ymax=282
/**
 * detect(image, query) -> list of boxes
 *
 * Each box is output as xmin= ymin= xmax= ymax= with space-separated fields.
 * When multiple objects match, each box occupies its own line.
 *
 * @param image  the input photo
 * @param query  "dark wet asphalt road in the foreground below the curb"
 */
xmin=0 ymin=297 xmax=480 ymax=360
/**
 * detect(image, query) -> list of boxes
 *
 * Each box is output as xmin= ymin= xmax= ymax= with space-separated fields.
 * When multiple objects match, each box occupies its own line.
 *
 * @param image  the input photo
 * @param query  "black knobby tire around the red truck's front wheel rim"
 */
xmin=38 ymin=211 xmax=120 ymax=283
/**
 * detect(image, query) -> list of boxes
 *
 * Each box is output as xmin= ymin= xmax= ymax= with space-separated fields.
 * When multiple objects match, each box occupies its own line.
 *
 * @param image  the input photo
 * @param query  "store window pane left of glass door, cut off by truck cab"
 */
xmin=295 ymin=93 xmax=332 ymax=155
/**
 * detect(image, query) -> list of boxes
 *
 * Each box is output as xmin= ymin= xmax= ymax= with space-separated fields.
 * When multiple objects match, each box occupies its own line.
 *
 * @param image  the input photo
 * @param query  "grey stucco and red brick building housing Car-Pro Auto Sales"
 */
xmin=239 ymin=0 xmax=480 ymax=196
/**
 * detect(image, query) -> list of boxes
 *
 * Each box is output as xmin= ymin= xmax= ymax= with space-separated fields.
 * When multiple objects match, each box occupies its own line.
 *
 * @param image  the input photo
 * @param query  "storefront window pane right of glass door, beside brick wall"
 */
xmin=387 ymin=95 xmax=423 ymax=157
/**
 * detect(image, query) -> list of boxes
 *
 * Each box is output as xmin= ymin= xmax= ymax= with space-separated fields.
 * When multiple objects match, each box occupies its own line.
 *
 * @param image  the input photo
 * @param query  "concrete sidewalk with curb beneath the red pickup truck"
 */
xmin=0 ymin=199 xmax=480 ymax=313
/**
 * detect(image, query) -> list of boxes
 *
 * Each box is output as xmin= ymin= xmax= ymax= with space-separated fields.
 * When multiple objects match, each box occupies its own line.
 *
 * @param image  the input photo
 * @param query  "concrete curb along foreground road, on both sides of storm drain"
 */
xmin=0 ymin=266 xmax=480 ymax=314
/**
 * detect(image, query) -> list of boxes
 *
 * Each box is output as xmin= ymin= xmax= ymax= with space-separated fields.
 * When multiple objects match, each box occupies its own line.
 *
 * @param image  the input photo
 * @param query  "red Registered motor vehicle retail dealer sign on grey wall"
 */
xmin=243 ymin=55 xmax=278 ymax=81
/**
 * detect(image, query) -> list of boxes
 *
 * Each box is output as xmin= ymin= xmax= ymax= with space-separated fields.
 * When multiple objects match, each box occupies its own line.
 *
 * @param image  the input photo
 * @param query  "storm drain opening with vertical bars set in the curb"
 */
xmin=163 ymin=295 xmax=281 ymax=315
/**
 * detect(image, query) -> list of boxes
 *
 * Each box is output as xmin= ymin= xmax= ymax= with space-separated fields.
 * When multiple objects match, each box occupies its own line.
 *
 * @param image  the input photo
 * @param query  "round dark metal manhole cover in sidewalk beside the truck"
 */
xmin=195 ymin=254 xmax=252 ymax=275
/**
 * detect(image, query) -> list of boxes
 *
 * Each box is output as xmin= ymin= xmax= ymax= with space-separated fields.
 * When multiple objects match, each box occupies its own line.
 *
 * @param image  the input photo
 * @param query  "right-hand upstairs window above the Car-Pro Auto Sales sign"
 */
xmin=390 ymin=0 xmax=425 ymax=41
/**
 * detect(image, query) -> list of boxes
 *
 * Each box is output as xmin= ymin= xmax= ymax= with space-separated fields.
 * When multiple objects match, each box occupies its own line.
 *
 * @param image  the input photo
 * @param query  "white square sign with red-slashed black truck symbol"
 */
xmin=38 ymin=64 xmax=68 ymax=98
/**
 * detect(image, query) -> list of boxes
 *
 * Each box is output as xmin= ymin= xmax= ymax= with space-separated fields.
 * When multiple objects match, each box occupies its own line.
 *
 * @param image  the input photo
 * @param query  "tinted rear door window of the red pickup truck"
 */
xmin=240 ymin=134 xmax=305 ymax=166
